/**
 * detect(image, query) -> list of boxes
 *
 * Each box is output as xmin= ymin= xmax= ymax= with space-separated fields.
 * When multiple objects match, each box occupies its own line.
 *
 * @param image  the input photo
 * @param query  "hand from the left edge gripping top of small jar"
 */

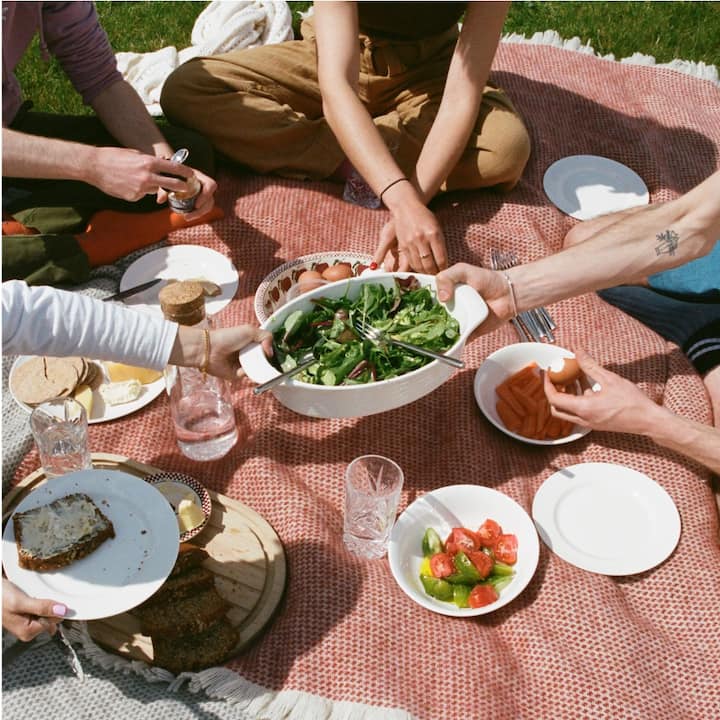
xmin=87 ymin=147 xmax=200 ymax=201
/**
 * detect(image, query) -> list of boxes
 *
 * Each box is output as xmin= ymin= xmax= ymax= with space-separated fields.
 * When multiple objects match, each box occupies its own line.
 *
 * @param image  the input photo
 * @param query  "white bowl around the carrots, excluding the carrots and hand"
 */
xmin=473 ymin=343 xmax=599 ymax=445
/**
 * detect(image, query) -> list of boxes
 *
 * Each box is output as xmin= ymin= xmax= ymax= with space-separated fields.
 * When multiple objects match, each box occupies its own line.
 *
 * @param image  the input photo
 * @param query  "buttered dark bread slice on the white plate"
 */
xmin=13 ymin=493 xmax=115 ymax=570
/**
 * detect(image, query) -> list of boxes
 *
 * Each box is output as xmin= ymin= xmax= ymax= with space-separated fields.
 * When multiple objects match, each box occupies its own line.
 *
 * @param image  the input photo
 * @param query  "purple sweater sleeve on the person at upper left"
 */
xmin=40 ymin=2 xmax=122 ymax=105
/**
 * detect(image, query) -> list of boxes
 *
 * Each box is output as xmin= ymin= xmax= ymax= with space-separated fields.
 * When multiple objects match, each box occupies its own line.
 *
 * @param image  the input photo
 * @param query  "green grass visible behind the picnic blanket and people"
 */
xmin=18 ymin=0 xmax=720 ymax=113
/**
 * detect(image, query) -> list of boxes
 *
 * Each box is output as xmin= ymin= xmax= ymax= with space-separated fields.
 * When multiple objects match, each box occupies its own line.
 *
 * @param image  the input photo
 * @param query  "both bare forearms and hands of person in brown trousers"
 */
xmin=315 ymin=2 xmax=507 ymax=272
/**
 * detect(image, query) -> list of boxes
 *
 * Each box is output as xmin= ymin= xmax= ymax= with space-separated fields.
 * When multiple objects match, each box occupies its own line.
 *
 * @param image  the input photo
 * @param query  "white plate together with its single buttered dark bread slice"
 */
xmin=2 ymin=468 xmax=178 ymax=620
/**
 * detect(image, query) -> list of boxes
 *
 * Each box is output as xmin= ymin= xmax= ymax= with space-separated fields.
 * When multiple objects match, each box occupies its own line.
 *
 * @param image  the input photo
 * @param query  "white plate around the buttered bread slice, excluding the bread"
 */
xmin=3 ymin=470 xmax=179 ymax=620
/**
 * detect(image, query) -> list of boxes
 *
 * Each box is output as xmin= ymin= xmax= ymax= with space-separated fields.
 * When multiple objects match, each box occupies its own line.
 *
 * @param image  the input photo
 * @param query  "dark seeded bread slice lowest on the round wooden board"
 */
xmin=153 ymin=618 xmax=239 ymax=674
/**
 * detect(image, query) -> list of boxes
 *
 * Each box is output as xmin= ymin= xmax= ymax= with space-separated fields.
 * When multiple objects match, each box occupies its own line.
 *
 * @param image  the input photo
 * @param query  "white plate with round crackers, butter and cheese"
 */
xmin=8 ymin=355 xmax=165 ymax=424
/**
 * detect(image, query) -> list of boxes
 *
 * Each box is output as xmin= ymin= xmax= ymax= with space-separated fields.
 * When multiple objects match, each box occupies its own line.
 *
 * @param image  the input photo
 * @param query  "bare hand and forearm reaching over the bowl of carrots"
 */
xmin=545 ymin=350 xmax=720 ymax=473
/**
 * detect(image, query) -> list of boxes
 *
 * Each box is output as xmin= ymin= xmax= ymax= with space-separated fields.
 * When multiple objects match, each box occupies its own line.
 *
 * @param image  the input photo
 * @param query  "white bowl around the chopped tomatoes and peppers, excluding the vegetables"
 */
xmin=388 ymin=485 xmax=540 ymax=617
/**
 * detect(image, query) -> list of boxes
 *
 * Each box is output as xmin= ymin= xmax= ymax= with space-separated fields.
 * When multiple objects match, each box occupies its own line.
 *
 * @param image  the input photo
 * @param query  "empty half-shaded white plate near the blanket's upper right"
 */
xmin=543 ymin=155 xmax=650 ymax=220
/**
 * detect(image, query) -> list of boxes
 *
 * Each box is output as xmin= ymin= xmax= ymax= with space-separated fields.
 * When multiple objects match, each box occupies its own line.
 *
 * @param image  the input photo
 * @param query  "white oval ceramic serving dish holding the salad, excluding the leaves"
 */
xmin=240 ymin=272 xmax=488 ymax=418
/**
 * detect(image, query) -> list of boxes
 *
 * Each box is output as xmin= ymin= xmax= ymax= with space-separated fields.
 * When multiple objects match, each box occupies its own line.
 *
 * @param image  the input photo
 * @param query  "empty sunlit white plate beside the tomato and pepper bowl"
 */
xmin=532 ymin=463 xmax=680 ymax=575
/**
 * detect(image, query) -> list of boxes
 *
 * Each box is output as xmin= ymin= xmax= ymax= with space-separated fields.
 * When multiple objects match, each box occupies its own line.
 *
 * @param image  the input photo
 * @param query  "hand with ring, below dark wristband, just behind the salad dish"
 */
xmin=373 ymin=202 xmax=447 ymax=275
